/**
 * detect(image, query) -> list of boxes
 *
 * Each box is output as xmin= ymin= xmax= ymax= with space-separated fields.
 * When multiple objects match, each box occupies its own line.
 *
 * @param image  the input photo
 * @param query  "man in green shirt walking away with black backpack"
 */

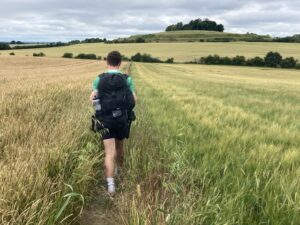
xmin=90 ymin=51 xmax=137 ymax=194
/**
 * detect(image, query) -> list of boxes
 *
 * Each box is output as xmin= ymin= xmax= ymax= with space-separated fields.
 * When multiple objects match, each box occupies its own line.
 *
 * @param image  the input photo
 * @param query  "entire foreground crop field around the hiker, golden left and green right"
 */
xmin=0 ymin=55 xmax=300 ymax=225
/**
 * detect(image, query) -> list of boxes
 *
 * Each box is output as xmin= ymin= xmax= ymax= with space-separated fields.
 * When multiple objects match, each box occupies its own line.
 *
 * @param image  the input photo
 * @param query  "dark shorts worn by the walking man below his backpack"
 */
xmin=101 ymin=124 xmax=130 ymax=140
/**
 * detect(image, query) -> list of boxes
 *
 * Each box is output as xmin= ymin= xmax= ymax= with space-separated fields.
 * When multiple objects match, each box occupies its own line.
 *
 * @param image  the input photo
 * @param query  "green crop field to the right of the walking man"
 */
xmin=120 ymin=64 xmax=300 ymax=225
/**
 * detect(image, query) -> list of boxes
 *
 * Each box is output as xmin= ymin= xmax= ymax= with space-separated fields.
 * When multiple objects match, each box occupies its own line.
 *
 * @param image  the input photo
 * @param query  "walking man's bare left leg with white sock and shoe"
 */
xmin=103 ymin=138 xmax=116 ymax=193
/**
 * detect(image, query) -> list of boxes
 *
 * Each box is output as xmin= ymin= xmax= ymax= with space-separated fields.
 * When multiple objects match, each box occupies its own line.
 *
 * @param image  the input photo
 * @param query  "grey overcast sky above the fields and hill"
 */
xmin=0 ymin=0 xmax=300 ymax=41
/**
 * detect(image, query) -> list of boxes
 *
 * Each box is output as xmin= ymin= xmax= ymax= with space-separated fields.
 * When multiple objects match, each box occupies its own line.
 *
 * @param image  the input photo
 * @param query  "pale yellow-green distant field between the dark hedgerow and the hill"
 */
xmin=0 ymin=42 xmax=300 ymax=62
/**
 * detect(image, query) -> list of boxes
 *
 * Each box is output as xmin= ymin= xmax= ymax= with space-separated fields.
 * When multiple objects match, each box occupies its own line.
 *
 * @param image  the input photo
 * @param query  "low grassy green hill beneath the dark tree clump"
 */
xmin=115 ymin=30 xmax=273 ymax=42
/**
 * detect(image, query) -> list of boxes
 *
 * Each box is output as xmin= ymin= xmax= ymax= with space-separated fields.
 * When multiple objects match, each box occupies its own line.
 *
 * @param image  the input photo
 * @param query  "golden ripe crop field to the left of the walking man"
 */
xmin=0 ymin=56 xmax=112 ymax=225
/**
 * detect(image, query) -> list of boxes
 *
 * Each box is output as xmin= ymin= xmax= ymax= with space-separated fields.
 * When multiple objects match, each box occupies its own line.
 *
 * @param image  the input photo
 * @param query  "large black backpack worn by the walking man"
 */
xmin=90 ymin=73 xmax=135 ymax=131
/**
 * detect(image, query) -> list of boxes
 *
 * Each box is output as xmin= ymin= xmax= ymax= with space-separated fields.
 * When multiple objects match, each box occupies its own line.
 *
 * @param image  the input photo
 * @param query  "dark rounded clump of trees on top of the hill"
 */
xmin=166 ymin=19 xmax=224 ymax=32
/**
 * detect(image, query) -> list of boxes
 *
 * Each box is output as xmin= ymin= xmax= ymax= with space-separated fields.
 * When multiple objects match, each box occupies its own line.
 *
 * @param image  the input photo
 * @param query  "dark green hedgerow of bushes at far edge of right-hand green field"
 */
xmin=190 ymin=52 xmax=298 ymax=68
